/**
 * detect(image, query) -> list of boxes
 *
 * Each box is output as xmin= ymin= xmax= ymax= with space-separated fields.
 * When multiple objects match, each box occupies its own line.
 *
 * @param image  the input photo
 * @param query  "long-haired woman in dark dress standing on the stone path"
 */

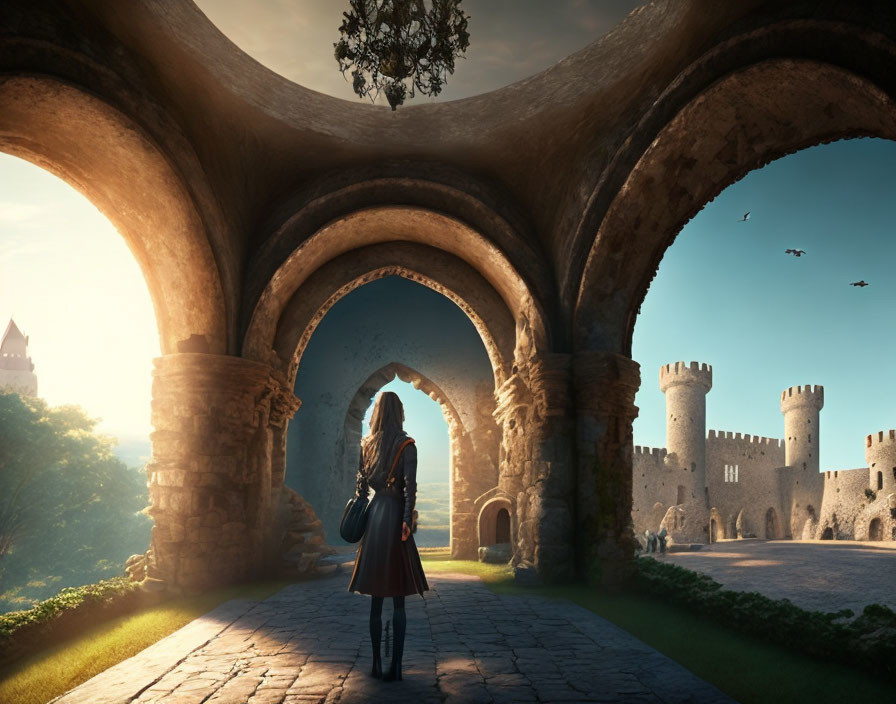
xmin=348 ymin=391 xmax=429 ymax=680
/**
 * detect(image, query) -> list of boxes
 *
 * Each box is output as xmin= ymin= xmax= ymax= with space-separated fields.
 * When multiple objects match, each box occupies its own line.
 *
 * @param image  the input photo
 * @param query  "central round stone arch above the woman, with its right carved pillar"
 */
xmin=243 ymin=206 xmax=575 ymax=581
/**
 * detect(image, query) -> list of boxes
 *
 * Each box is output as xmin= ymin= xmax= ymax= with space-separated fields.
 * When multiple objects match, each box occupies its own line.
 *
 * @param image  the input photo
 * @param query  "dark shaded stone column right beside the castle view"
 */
xmin=573 ymin=351 xmax=641 ymax=587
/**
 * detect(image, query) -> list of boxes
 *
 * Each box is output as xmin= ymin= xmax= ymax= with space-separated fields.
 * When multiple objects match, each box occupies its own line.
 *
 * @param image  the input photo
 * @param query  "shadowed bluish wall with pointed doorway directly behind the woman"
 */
xmin=285 ymin=277 xmax=499 ymax=558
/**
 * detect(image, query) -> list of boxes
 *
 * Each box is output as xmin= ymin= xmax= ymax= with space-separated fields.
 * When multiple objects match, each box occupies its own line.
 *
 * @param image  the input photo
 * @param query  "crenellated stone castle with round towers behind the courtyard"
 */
xmin=632 ymin=362 xmax=896 ymax=543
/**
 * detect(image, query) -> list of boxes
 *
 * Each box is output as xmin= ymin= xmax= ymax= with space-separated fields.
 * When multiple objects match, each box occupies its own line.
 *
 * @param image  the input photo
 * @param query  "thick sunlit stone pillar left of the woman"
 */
xmin=146 ymin=353 xmax=299 ymax=589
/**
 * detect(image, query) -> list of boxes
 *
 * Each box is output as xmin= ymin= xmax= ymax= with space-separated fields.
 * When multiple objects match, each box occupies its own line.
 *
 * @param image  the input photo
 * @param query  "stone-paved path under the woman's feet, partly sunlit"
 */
xmin=54 ymin=570 xmax=732 ymax=704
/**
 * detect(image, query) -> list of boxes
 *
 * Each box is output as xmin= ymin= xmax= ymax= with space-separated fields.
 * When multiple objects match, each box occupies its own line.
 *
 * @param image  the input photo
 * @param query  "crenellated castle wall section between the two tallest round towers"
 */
xmin=706 ymin=430 xmax=787 ymax=538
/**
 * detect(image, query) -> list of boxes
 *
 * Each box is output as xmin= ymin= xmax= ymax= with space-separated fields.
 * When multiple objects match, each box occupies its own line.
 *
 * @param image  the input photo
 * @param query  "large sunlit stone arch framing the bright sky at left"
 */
xmin=0 ymin=76 xmax=229 ymax=354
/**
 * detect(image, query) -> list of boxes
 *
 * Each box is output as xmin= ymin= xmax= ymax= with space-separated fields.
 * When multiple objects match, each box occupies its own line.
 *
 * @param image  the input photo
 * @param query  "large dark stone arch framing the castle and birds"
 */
xmin=565 ymin=40 xmax=896 ymax=588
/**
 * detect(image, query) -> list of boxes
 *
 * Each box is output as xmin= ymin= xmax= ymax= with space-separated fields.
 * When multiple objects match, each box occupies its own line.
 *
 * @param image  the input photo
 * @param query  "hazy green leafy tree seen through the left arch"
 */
xmin=0 ymin=394 xmax=151 ymax=601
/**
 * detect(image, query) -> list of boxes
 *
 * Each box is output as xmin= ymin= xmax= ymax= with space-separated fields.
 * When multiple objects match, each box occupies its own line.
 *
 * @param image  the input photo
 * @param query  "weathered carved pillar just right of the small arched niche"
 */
xmin=495 ymin=354 xmax=575 ymax=583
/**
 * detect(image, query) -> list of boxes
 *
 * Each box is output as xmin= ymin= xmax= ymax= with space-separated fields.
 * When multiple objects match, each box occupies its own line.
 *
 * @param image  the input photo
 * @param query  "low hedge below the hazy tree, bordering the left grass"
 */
xmin=0 ymin=577 xmax=159 ymax=665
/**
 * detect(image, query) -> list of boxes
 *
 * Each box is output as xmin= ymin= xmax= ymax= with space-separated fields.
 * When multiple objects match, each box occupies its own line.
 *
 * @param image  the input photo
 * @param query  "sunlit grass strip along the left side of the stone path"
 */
xmin=0 ymin=581 xmax=288 ymax=704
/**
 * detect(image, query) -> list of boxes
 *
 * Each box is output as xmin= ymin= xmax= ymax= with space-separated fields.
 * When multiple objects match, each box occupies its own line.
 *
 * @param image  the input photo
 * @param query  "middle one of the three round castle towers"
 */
xmin=781 ymin=385 xmax=824 ymax=540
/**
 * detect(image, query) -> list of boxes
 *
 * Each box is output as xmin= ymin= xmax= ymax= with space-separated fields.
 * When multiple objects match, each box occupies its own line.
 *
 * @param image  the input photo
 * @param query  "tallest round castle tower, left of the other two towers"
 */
xmin=660 ymin=362 xmax=712 ymax=509
